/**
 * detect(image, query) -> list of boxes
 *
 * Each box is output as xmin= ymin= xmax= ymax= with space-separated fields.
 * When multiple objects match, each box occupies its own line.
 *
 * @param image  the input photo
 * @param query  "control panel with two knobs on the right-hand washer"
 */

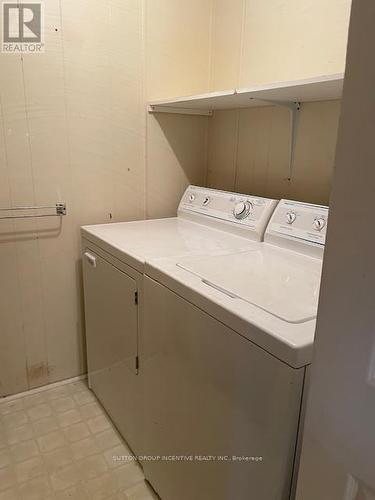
xmin=266 ymin=200 xmax=328 ymax=247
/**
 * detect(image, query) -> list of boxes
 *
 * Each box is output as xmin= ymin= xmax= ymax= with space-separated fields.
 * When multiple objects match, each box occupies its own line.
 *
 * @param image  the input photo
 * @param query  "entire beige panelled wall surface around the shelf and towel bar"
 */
xmin=0 ymin=0 xmax=349 ymax=395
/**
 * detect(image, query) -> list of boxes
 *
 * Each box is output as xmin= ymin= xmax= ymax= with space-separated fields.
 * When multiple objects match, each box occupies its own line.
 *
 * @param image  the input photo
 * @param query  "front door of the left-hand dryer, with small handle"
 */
xmin=83 ymin=250 xmax=139 ymax=445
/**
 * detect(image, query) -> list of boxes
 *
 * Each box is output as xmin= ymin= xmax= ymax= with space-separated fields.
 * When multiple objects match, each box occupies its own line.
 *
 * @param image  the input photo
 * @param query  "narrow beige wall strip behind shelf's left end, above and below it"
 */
xmin=145 ymin=0 xmax=213 ymax=218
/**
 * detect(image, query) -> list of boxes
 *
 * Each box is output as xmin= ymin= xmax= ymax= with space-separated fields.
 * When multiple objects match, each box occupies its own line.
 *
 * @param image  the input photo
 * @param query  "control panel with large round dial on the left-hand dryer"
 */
xmin=178 ymin=186 xmax=277 ymax=241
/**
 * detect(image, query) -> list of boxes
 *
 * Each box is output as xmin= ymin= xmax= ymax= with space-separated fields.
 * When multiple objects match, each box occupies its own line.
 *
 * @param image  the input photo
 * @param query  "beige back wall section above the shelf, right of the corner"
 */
xmin=210 ymin=0 xmax=351 ymax=90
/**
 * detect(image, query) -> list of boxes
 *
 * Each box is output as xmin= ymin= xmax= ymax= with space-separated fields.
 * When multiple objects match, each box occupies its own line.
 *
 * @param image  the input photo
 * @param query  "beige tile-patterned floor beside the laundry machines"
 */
xmin=0 ymin=381 xmax=156 ymax=500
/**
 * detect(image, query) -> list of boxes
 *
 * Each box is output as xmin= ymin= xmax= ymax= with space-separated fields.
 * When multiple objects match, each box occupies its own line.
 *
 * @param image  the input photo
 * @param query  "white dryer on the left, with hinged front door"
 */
xmin=82 ymin=186 xmax=277 ymax=454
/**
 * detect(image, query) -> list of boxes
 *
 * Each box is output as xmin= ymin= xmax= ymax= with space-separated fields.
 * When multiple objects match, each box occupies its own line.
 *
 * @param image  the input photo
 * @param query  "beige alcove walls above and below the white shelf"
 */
xmin=146 ymin=0 xmax=351 ymax=217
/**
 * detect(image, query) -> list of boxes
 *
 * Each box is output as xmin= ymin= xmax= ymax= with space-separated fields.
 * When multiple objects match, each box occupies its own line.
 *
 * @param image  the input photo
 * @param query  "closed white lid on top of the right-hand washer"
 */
xmin=177 ymin=245 xmax=322 ymax=323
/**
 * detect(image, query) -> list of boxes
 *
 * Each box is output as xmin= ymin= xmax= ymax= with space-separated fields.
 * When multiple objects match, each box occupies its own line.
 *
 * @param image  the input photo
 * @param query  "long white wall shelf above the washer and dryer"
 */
xmin=148 ymin=73 xmax=344 ymax=116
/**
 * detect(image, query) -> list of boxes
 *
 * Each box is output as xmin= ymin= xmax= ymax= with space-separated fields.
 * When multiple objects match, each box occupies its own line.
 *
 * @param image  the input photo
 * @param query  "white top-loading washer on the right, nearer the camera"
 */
xmin=143 ymin=200 xmax=328 ymax=500
